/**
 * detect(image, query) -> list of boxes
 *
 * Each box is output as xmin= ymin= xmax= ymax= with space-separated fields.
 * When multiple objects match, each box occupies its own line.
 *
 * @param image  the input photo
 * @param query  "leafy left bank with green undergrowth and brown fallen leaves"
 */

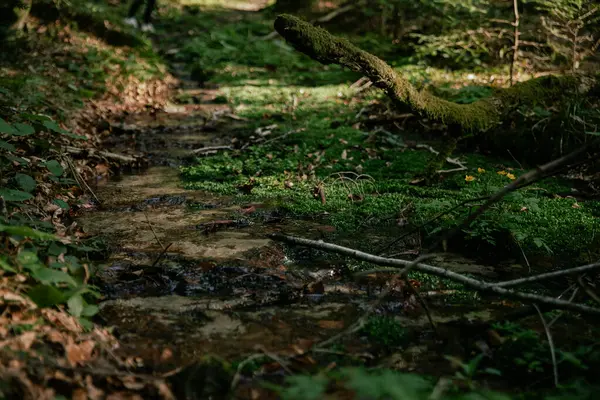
xmin=0 ymin=1 xmax=165 ymax=327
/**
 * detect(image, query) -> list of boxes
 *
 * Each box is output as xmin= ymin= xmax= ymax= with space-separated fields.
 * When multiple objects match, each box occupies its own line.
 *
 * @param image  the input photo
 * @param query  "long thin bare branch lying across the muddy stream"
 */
xmin=268 ymin=233 xmax=600 ymax=315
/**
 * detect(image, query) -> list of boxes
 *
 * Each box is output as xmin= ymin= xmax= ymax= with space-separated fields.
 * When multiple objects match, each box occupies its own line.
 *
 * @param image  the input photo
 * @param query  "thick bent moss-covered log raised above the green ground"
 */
xmin=275 ymin=14 xmax=595 ymax=136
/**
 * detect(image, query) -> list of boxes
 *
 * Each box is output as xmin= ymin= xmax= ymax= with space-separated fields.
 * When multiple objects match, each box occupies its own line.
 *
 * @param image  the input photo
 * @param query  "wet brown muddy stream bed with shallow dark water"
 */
xmin=79 ymin=69 xmax=504 ymax=384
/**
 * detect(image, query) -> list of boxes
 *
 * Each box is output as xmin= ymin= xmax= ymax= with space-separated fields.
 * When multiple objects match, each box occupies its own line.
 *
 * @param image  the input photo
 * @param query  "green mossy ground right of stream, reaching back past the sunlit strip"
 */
xmin=177 ymin=4 xmax=600 ymax=263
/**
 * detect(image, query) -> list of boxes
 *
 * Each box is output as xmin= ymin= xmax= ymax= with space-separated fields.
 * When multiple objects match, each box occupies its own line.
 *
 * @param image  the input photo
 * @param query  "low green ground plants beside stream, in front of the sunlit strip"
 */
xmin=182 ymin=108 xmax=600 ymax=257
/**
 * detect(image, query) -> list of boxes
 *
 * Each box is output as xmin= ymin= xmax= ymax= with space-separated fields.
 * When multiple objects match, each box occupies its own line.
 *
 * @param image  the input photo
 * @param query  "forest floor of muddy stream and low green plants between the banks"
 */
xmin=1 ymin=2 xmax=600 ymax=399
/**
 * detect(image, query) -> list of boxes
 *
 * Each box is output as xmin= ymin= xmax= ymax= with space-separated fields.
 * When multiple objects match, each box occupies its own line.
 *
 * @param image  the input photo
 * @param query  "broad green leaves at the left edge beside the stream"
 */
xmin=0 ymin=113 xmax=99 ymax=323
